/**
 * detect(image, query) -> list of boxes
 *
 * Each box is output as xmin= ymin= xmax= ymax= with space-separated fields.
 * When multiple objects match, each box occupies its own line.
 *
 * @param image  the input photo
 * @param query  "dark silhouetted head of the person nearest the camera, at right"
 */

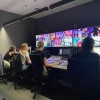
xmin=82 ymin=37 xmax=94 ymax=52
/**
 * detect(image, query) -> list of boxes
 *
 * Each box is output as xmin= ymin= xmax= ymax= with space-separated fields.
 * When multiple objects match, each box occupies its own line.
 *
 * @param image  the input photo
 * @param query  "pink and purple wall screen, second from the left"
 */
xmin=51 ymin=30 xmax=72 ymax=47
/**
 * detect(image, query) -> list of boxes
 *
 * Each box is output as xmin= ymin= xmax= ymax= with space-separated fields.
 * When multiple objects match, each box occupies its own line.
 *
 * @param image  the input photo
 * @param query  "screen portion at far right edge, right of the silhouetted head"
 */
xmin=91 ymin=26 xmax=100 ymax=46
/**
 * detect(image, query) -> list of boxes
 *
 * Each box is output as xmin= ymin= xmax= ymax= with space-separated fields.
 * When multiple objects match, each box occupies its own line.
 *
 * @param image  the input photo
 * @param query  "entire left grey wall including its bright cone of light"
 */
xmin=0 ymin=11 xmax=35 ymax=55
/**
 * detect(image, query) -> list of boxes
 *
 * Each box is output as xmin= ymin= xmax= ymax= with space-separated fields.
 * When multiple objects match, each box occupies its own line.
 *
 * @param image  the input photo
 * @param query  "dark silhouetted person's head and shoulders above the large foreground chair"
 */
xmin=72 ymin=37 xmax=100 ymax=59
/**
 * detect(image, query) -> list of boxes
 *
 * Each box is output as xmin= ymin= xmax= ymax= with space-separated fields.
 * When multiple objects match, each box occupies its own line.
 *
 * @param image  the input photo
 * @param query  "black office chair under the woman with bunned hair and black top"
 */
xmin=30 ymin=54 xmax=47 ymax=99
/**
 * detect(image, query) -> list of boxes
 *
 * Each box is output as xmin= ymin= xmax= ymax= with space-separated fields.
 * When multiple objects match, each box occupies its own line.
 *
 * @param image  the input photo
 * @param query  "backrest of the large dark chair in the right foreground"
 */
xmin=69 ymin=58 xmax=100 ymax=81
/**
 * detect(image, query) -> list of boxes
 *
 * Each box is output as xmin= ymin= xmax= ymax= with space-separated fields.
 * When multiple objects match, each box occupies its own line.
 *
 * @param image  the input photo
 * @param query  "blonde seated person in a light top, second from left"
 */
xmin=19 ymin=43 xmax=31 ymax=70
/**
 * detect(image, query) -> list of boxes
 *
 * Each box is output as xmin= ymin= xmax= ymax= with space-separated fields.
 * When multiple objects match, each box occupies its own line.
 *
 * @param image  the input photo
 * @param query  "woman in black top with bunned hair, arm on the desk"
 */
xmin=34 ymin=41 xmax=58 ymax=76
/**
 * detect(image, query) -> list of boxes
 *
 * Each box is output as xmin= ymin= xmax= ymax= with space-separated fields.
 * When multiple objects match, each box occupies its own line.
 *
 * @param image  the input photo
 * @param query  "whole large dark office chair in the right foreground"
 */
xmin=68 ymin=58 xmax=100 ymax=100
